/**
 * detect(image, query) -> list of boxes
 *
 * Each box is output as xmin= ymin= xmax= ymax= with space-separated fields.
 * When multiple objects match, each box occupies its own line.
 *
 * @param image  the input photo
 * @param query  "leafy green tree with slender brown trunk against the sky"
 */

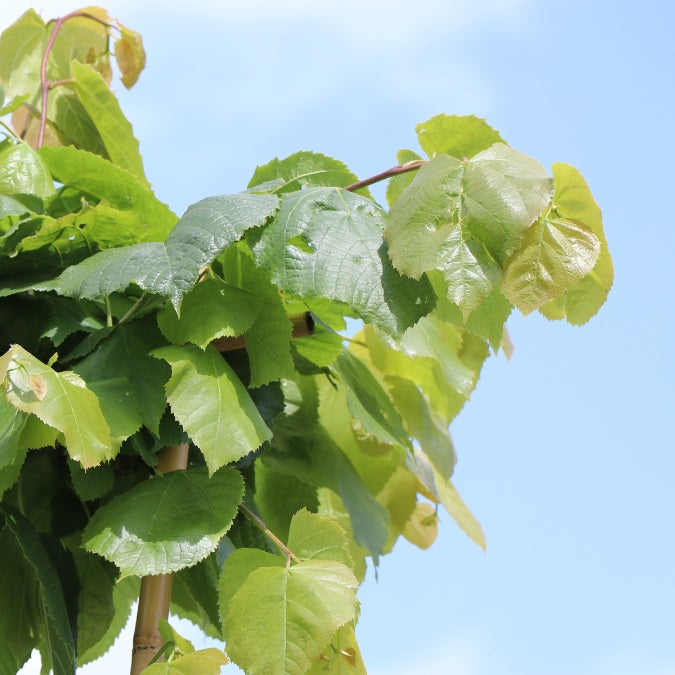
xmin=0 ymin=8 xmax=613 ymax=673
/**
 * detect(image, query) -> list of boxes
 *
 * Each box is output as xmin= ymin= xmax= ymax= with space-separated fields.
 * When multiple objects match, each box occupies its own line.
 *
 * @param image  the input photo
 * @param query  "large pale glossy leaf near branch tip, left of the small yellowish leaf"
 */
xmin=385 ymin=144 xmax=551 ymax=292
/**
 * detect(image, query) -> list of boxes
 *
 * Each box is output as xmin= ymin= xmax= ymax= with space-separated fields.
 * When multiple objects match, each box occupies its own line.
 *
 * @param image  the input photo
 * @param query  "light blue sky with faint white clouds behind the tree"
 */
xmin=6 ymin=0 xmax=675 ymax=675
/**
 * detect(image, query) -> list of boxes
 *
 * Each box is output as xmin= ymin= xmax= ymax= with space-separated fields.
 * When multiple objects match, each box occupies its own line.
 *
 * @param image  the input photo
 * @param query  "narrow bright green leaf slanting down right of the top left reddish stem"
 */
xmin=71 ymin=61 xmax=149 ymax=186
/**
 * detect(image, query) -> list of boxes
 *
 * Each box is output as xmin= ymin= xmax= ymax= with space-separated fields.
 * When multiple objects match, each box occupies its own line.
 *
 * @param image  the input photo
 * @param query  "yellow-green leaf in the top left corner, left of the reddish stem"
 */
xmin=0 ymin=9 xmax=47 ymax=97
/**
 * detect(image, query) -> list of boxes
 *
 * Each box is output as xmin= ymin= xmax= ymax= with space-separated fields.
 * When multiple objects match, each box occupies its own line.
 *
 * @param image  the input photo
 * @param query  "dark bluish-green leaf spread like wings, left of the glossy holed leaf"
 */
xmin=49 ymin=187 xmax=277 ymax=311
